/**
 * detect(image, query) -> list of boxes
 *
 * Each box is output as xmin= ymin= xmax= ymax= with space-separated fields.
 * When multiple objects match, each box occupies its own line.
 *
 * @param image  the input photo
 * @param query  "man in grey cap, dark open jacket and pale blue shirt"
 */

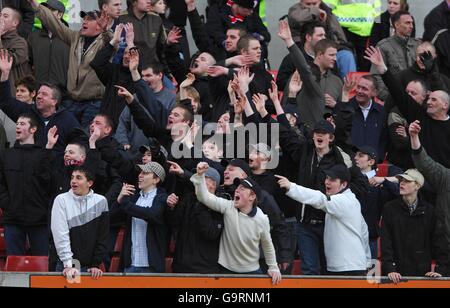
xmin=116 ymin=162 xmax=169 ymax=273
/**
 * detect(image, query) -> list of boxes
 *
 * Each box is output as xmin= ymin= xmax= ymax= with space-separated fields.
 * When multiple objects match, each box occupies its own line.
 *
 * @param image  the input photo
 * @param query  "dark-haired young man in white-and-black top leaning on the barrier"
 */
xmin=51 ymin=167 xmax=109 ymax=279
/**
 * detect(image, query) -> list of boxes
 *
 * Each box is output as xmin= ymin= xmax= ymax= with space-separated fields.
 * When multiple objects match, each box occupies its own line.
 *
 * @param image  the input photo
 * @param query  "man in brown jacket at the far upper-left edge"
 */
xmin=0 ymin=7 xmax=31 ymax=95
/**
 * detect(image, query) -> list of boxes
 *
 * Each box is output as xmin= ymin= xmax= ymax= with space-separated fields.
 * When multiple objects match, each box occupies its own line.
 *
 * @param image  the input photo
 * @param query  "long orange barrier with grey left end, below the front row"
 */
xmin=0 ymin=272 xmax=450 ymax=289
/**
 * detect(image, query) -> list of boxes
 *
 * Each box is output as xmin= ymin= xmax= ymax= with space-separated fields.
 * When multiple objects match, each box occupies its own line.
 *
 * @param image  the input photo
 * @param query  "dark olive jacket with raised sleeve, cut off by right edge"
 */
xmin=412 ymin=147 xmax=450 ymax=276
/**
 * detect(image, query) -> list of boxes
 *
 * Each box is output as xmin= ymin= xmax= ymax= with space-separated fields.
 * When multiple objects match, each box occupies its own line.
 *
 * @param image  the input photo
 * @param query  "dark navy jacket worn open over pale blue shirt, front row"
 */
xmin=115 ymin=188 xmax=170 ymax=273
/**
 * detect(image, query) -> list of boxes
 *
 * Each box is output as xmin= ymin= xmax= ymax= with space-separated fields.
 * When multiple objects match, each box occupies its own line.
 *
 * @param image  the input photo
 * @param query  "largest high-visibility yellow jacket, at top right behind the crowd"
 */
xmin=324 ymin=0 xmax=382 ymax=37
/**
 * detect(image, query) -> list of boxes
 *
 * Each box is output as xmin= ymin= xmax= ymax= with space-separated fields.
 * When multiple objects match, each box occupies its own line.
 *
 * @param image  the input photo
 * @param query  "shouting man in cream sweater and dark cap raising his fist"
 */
xmin=191 ymin=162 xmax=281 ymax=284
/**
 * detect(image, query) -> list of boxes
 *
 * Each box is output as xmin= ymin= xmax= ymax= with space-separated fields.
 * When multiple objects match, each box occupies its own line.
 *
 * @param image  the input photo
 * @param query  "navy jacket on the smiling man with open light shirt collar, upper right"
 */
xmin=348 ymin=98 xmax=387 ymax=160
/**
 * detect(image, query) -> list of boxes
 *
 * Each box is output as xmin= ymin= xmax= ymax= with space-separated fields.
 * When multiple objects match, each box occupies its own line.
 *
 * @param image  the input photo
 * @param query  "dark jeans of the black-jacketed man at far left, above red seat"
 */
xmin=5 ymin=225 xmax=49 ymax=256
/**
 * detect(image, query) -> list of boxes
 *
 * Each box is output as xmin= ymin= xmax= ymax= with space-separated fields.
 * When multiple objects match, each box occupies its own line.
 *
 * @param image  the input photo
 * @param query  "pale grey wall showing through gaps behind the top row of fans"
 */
xmin=71 ymin=0 xmax=442 ymax=69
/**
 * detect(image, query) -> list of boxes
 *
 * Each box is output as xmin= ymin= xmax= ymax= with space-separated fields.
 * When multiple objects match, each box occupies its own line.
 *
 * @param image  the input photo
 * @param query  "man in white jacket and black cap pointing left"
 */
xmin=276 ymin=165 xmax=371 ymax=276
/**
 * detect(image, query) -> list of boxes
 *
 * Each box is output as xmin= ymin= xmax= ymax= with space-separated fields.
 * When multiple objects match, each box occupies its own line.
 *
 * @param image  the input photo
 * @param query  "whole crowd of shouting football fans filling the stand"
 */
xmin=0 ymin=0 xmax=450 ymax=284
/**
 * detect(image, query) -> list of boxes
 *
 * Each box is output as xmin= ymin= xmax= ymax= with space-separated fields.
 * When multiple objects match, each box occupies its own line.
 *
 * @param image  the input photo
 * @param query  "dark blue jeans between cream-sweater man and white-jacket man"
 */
xmin=297 ymin=222 xmax=327 ymax=275
